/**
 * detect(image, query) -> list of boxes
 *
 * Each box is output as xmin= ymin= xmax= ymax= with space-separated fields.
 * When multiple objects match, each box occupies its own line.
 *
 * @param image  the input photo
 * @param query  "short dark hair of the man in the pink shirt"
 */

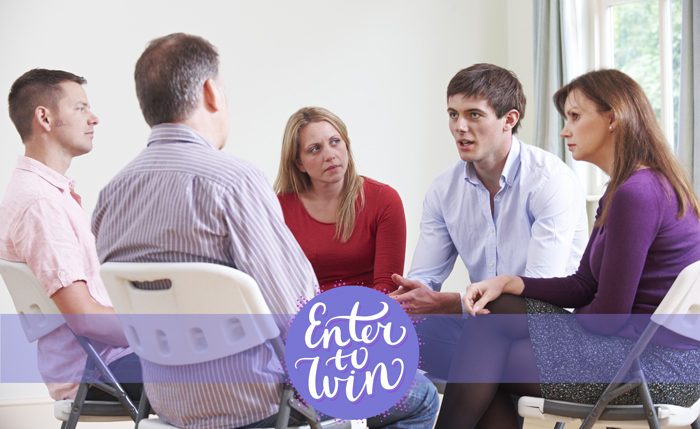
xmin=7 ymin=69 xmax=87 ymax=142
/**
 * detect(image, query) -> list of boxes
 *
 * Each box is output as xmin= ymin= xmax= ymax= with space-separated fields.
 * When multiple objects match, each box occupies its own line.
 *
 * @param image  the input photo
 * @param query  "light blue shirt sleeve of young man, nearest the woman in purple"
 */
xmin=525 ymin=172 xmax=588 ymax=278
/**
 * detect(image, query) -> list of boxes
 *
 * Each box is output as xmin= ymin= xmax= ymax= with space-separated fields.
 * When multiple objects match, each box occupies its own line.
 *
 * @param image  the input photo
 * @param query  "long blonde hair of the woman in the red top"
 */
xmin=274 ymin=107 xmax=365 ymax=243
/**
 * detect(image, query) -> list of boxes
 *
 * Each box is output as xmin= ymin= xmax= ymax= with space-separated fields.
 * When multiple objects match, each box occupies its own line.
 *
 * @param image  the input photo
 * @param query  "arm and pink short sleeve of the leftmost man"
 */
xmin=12 ymin=199 xmax=128 ymax=346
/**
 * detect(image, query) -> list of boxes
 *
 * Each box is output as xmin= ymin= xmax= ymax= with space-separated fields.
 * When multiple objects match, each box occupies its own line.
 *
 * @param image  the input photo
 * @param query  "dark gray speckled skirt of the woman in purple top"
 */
xmin=526 ymin=298 xmax=700 ymax=407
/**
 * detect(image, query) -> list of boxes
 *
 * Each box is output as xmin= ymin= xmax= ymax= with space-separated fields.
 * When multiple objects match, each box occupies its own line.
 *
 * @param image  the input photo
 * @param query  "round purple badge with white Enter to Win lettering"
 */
xmin=285 ymin=286 xmax=419 ymax=420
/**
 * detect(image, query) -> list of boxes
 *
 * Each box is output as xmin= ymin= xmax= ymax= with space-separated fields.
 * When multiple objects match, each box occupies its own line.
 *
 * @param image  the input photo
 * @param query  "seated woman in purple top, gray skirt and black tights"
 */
xmin=437 ymin=70 xmax=700 ymax=428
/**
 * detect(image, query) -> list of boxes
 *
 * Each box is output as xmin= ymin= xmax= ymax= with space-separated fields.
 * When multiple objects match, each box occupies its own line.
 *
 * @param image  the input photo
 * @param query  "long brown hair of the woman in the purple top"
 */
xmin=554 ymin=69 xmax=700 ymax=227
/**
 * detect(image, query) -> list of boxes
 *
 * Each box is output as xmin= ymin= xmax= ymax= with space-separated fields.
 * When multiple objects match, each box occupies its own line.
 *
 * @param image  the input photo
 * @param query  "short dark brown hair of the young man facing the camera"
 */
xmin=447 ymin=63 xmax=527 ymax=134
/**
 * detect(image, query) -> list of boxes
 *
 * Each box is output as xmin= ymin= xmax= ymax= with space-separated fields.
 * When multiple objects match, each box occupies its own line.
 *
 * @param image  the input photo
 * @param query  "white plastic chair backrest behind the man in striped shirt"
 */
xmin=100 ymin=262 xmax=280 ymax=365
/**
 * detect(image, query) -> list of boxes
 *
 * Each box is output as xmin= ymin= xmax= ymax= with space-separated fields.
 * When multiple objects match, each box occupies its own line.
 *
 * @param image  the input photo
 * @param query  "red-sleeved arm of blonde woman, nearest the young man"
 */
xmin=373 ymin=186 xmax=406 ymax=293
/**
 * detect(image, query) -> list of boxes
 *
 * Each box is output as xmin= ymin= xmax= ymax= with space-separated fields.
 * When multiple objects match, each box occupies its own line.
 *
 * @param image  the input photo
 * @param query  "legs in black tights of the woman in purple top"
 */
xmin=436 ymin=294 xmax=542 ymax=429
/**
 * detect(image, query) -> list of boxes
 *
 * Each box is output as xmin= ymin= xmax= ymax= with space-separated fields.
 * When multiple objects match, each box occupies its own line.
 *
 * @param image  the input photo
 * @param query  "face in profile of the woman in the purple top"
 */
xmin=559 ymin=89 xmax=615 ymax=174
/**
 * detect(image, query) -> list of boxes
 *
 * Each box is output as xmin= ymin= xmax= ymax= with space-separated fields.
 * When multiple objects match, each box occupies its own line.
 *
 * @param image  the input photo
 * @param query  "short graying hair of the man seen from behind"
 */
xmin=134 ymin=33 xmax=219 ymax=126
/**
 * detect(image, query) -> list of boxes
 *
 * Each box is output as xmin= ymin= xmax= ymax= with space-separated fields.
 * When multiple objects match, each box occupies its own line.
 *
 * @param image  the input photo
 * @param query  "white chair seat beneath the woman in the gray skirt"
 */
xmin=518 ymin=396 xmax=700 ymax=428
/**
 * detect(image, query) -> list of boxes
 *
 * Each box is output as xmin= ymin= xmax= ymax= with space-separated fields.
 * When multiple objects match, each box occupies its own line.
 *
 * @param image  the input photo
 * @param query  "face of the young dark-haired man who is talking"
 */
xmin=447 ymin=94 xmax=510 ymax=165
